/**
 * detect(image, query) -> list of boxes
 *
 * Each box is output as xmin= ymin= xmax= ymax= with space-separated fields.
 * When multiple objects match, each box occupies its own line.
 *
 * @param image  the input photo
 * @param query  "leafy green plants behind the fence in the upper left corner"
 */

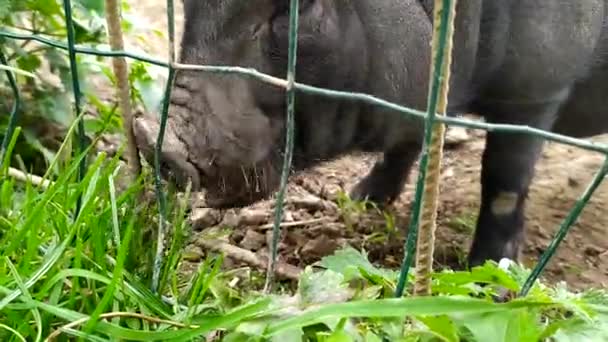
xmin=0 ymin=0 xmax=163 ymax=173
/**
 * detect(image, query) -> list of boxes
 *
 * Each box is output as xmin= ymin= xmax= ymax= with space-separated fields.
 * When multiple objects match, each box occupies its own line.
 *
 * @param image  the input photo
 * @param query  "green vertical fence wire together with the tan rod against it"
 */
xmin=395 ymin=0 xmax=456 ymax=297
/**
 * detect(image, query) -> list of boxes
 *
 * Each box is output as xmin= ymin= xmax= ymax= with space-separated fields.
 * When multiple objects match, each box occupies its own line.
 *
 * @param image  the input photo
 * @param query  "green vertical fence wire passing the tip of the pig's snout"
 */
xmin=152 ymin=0 xmax=175 ymax=292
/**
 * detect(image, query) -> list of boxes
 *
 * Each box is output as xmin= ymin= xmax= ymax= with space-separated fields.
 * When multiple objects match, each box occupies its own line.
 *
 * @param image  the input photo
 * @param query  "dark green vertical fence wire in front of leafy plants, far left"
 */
xmin=63 ymin=0 xmax=87 ymax=216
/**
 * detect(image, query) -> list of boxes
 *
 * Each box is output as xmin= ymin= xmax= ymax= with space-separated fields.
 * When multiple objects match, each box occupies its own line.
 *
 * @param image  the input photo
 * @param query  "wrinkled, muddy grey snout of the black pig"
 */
xmin=134 ymin=76 xmax=282 ymax=207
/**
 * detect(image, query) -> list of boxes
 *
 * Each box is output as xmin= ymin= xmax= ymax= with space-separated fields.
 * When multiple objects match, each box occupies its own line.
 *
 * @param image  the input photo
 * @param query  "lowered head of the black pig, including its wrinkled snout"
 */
xmin=133 ymin=0 xmax=366 ymax=207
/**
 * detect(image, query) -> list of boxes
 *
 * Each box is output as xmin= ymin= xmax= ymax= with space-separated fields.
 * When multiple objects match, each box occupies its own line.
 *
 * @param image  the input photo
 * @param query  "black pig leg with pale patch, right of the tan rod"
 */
xmin=469 ymin=102 xmax=561 ymax=267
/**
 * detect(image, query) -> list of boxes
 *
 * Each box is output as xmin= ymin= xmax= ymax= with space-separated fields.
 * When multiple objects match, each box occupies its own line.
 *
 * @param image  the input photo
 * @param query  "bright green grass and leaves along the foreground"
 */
xmin=0 ymin=126 xmax=608 ymax=341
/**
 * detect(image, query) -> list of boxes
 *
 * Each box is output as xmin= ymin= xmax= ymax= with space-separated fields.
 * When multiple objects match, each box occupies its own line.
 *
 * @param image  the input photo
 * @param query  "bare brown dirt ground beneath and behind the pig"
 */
xmin=124 ymin=0 xmax=608 ymax=289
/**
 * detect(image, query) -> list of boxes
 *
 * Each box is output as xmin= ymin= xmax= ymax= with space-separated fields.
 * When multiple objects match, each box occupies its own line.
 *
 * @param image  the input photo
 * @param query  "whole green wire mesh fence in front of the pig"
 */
xmin=0 ymin=0 xmax=608 ymax=296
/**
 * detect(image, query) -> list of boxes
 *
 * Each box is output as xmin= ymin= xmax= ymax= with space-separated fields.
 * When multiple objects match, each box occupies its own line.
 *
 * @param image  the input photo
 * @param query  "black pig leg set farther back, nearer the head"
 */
xmin=350 ymin=142 xmax=420 ymax=207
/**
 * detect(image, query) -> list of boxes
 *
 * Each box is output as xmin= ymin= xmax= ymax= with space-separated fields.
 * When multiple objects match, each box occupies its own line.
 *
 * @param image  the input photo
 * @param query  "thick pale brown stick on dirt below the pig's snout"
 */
xmin=196 ymin=238 xmax=302 ymax=280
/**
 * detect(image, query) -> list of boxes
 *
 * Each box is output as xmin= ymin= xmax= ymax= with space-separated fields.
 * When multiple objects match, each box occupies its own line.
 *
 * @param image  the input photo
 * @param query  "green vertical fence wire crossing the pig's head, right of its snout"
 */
xmin=264 ymin=0 xmax=299 ymax=293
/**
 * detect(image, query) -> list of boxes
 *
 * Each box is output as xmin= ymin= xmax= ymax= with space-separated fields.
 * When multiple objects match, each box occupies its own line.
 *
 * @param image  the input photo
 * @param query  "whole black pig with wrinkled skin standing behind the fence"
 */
xmin=136 ymin=0 xmax=608 ymax=266
